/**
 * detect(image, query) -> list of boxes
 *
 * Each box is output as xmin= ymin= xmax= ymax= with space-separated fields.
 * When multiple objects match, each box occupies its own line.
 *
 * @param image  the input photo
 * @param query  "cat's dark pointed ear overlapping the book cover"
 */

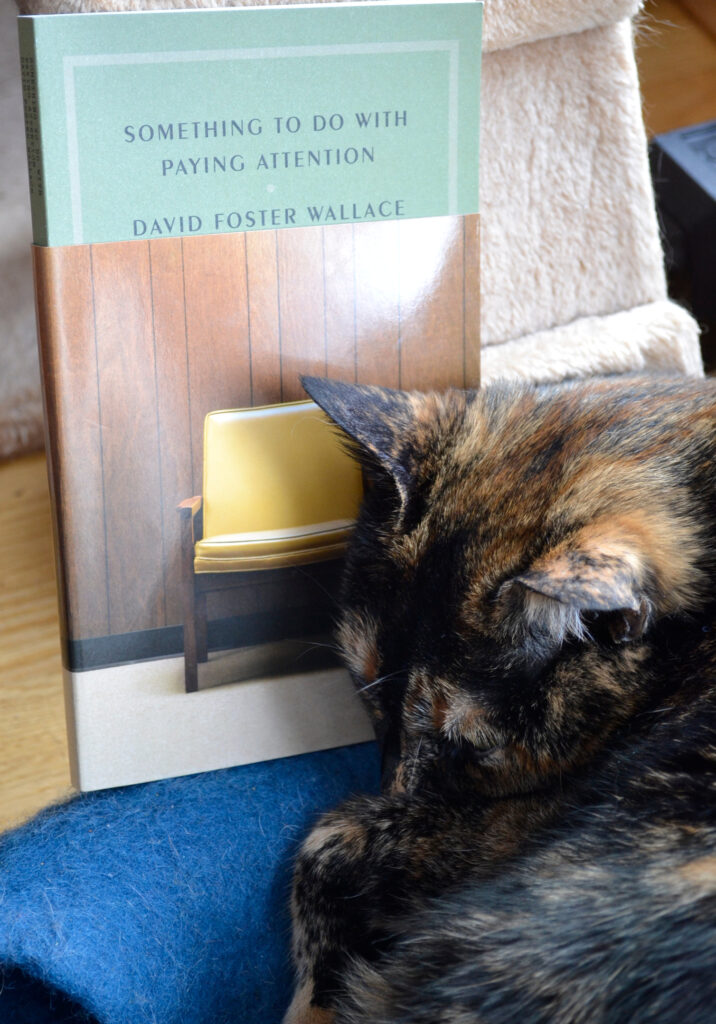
xmin=301 ymin=377 xmax=422 ymax=520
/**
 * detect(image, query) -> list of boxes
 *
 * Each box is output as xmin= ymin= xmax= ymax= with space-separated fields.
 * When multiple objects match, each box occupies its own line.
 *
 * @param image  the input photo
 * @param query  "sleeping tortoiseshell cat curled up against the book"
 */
xmin=286 ymin=378 xmax=716 ymax=1024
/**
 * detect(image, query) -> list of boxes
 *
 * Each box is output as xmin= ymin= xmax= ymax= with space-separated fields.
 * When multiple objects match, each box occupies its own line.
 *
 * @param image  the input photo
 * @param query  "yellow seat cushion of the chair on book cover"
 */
xmin=194 ymin=519 xmax=353 ymax=572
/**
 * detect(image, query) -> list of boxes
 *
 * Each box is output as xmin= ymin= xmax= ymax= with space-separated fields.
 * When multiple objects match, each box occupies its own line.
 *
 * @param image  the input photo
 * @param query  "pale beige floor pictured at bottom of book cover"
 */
xmin=65 ymin=654 xmax=374 ymax=791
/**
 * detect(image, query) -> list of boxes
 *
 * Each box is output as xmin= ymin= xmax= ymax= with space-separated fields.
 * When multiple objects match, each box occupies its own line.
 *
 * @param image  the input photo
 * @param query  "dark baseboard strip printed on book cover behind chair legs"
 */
xmin=68 ymin=609 xmax=341 ymax=672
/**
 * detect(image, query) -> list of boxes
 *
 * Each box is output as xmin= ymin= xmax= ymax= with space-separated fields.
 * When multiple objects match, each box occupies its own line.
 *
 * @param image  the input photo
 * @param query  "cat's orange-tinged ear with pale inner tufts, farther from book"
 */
xmin=512 ymin=524 xmax=651 ymax=642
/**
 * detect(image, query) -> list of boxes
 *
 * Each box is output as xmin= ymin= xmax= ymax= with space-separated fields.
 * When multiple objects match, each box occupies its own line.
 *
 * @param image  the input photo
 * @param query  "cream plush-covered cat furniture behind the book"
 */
xmin=0 ymin=0 xmax=702 ymax=456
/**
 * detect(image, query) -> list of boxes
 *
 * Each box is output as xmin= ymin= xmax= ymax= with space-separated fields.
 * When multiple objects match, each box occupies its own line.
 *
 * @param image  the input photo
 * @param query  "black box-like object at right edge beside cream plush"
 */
xmin=649 ymin=121 xmax=716 ymax=372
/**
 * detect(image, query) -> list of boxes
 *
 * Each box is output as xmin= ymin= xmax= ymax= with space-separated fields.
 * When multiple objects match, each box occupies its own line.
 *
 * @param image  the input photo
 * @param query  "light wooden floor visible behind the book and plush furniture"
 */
xmin=0 ymin=0 xmax=716 ymax=827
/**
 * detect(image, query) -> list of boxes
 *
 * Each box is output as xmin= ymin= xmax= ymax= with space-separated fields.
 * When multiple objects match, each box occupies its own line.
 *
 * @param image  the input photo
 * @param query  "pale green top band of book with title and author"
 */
xmin=18 ymin=0 xmax=481 ymax=246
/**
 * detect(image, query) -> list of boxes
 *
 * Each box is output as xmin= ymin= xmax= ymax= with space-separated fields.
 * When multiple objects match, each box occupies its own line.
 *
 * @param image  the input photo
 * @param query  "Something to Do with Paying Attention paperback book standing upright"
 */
xmin=18 ymin=0 xmax=481 ymax=790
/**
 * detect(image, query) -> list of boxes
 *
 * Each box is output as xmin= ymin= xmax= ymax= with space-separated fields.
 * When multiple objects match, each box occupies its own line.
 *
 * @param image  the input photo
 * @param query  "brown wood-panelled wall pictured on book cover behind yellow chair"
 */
xmin=34 ymin=216 xmax=479 ymax=667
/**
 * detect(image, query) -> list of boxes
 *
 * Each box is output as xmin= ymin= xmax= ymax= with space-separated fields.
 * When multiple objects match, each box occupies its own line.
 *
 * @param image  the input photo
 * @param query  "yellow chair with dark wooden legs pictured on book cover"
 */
xmin=179 ymin=401 xmax=363 ymax=691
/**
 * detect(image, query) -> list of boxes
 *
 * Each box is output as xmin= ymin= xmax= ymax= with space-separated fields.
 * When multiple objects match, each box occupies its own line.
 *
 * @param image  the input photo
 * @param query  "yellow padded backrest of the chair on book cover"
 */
xmin=203 ymin=401 xmax=363 ymax=537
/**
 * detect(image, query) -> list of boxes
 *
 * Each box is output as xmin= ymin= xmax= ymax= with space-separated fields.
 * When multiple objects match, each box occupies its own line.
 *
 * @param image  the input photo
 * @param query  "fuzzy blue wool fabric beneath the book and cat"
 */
xmin=0 ymin=743 xmax=379 ymax=1024
